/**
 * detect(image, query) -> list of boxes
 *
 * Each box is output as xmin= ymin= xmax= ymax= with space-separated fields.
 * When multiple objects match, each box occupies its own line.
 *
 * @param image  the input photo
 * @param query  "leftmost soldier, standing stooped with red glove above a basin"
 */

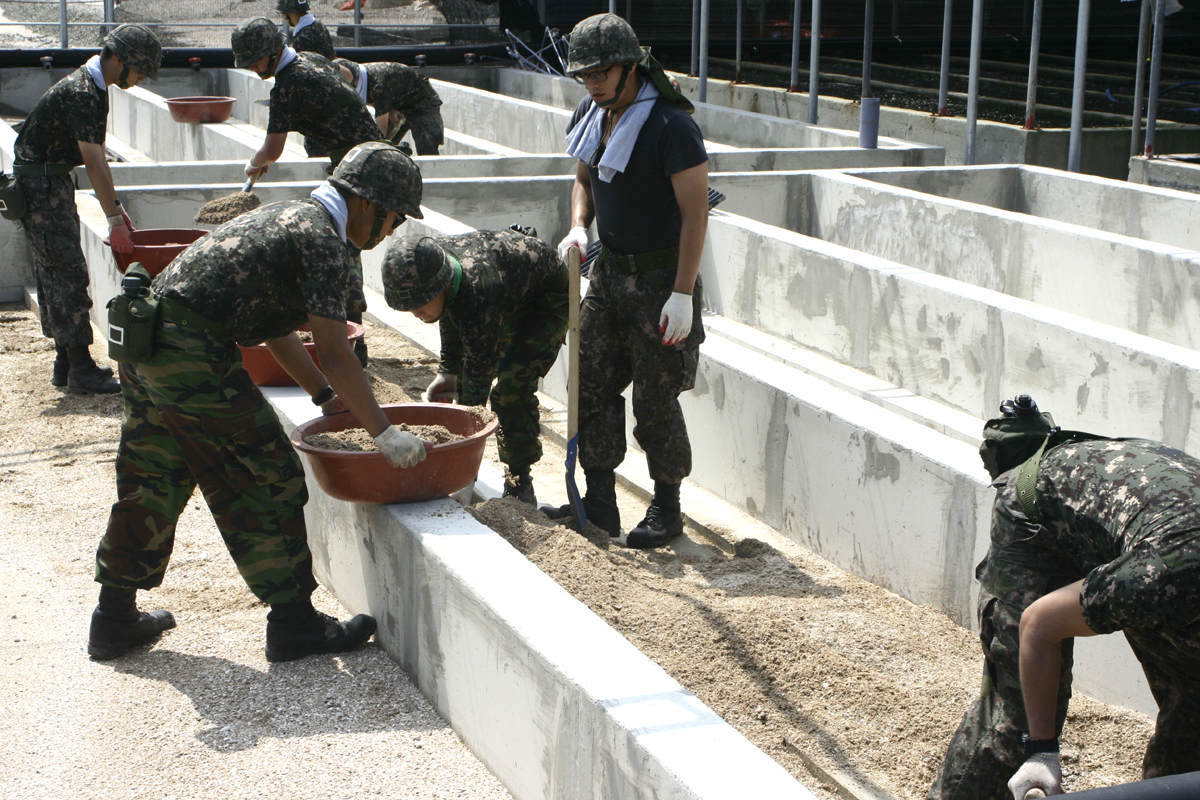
xmin=13 ymin=25 xmax=162 ymax=393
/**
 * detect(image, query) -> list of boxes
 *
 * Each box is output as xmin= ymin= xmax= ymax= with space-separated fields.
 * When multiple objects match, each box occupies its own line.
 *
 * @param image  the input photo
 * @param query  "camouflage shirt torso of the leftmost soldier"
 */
xmin=13 ymin=66 xmax=108 ymax=167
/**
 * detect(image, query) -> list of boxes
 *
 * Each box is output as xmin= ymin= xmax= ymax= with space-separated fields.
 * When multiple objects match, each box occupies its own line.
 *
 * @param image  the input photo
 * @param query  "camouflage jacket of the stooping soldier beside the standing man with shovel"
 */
xmin=434 ymin=230 xmax=566 ymax=405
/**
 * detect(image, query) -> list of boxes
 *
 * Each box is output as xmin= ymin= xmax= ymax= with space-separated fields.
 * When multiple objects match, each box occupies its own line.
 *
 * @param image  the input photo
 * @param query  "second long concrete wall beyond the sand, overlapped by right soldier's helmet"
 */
xmin=701 ymin=211 xmax=1200 ymax=452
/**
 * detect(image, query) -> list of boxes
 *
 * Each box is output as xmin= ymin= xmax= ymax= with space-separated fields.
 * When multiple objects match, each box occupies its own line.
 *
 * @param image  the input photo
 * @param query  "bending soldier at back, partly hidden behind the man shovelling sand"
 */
xmin=335 ymin=59 xmax=445 ymax=156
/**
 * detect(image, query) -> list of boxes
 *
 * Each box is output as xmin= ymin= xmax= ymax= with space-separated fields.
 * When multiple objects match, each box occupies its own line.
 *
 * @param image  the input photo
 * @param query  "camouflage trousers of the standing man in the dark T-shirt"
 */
xmin=580 ymin=261 xmax=704 ymax=483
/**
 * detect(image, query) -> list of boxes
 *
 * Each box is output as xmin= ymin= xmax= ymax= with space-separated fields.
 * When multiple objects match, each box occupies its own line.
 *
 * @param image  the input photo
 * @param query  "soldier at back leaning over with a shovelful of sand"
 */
xmin=232 ymin=17 xmax=379 ymax=366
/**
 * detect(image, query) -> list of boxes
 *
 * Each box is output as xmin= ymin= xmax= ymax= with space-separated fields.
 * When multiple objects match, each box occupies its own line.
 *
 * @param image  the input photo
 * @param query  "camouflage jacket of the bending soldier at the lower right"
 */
xmin=978 ymin=439 xmax=1200 ymax=648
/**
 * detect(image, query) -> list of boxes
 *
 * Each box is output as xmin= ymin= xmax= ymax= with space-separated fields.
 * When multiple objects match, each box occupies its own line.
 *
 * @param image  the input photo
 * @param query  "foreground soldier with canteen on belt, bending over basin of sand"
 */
xmin=88 ymin=143 xmax=425 ymax=661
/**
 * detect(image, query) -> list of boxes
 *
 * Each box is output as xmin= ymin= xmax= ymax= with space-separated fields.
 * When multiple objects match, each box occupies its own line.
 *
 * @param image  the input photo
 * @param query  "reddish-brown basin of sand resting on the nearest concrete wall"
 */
xmin=292 ymin=403 xmax=499 ymax=503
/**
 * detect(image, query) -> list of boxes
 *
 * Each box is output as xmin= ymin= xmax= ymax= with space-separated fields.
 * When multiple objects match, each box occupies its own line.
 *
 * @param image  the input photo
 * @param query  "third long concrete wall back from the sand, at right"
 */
xmin=788 ymin=173 xmax=1200 ymax=348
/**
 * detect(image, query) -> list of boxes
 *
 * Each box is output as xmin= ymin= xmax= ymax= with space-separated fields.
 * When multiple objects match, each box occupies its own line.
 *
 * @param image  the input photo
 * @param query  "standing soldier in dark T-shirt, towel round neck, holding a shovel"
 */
xmin=548 ymin=14 xmax=708 ymax=548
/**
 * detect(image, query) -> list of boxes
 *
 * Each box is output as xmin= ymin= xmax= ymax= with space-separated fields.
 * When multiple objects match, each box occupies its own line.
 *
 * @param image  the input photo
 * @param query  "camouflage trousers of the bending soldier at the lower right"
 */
xmin=929 ymin=489 xmax=1200 ymax=800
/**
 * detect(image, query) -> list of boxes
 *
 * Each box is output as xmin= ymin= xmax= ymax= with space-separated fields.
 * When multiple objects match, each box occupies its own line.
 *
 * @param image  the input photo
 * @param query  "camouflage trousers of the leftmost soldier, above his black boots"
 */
xmin=19 ymin=173 xmax=92 ymax=347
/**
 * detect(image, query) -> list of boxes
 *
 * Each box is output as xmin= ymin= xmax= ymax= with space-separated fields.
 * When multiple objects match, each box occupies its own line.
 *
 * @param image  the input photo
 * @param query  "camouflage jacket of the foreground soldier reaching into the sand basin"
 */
xmin=154 ymin=199 xmax=355 ymax=344
